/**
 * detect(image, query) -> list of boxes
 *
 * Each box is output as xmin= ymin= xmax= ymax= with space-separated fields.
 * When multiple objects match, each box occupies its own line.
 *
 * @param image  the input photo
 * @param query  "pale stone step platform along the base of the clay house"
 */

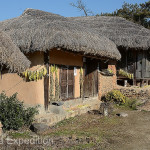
xmin=36 ymin=97 xmax=101 ymax=126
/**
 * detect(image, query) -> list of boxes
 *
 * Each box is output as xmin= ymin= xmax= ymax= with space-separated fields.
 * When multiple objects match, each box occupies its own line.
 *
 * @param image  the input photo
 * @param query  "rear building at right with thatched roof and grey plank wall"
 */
xmin=68 ymin=16 xmax=150 ymax=84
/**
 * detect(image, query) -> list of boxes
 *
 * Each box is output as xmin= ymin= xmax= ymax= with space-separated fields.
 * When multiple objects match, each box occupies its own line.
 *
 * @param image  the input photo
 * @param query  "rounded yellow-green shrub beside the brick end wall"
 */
xmin=103 ymin=90 xmax=126 ymax=105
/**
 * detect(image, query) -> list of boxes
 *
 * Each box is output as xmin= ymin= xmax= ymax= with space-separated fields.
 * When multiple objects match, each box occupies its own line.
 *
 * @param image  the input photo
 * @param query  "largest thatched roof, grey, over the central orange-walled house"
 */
xmin=0 ymin=9 xmax=121 ymax=59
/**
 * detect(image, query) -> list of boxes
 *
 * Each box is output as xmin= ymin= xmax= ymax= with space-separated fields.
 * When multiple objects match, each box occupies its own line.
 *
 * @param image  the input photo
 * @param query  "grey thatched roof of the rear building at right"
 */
xmin=68 ymin=16 xmax=150 ymax=50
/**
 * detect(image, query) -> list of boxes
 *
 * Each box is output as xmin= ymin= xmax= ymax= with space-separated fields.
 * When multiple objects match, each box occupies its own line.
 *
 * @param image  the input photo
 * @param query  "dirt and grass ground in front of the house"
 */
xmin=0 ymin=105 xmax=150 ymax=150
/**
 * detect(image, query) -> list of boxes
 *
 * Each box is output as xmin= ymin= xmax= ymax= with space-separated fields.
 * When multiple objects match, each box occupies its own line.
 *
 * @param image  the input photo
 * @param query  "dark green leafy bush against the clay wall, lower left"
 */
xmin=0 ymin=92 xmax=38 ymax=130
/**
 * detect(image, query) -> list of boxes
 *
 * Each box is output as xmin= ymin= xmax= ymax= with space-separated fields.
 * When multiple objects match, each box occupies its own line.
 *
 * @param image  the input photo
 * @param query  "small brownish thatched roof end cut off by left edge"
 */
xmin=0 ymin=31 xmax=30 ymax=72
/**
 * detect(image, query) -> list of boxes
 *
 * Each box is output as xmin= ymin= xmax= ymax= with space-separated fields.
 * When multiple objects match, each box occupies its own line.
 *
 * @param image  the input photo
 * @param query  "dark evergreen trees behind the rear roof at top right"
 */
xmin=100 ymin=0 xmax=150 ymax=28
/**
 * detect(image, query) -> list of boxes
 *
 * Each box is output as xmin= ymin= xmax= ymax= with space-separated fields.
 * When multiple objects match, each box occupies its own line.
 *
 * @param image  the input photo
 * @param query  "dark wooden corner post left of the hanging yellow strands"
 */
xmin=44 ymin=51 xmax=50 ymax=110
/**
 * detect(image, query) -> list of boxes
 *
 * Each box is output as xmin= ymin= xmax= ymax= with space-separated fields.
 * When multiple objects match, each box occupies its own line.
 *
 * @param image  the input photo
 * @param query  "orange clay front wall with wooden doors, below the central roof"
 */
xmin=0 ymin=49 xmax=116 ymax=109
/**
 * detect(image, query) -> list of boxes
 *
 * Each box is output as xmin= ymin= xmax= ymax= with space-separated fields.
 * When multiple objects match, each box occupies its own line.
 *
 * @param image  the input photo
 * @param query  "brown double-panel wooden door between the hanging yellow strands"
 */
xmin=60 ymin=67 xmax=74 ymax=100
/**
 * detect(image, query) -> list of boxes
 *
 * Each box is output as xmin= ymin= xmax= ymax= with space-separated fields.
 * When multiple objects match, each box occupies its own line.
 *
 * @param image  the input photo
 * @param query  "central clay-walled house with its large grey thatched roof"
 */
xmin=0 ymin=9 xmax=121 ymax=109
